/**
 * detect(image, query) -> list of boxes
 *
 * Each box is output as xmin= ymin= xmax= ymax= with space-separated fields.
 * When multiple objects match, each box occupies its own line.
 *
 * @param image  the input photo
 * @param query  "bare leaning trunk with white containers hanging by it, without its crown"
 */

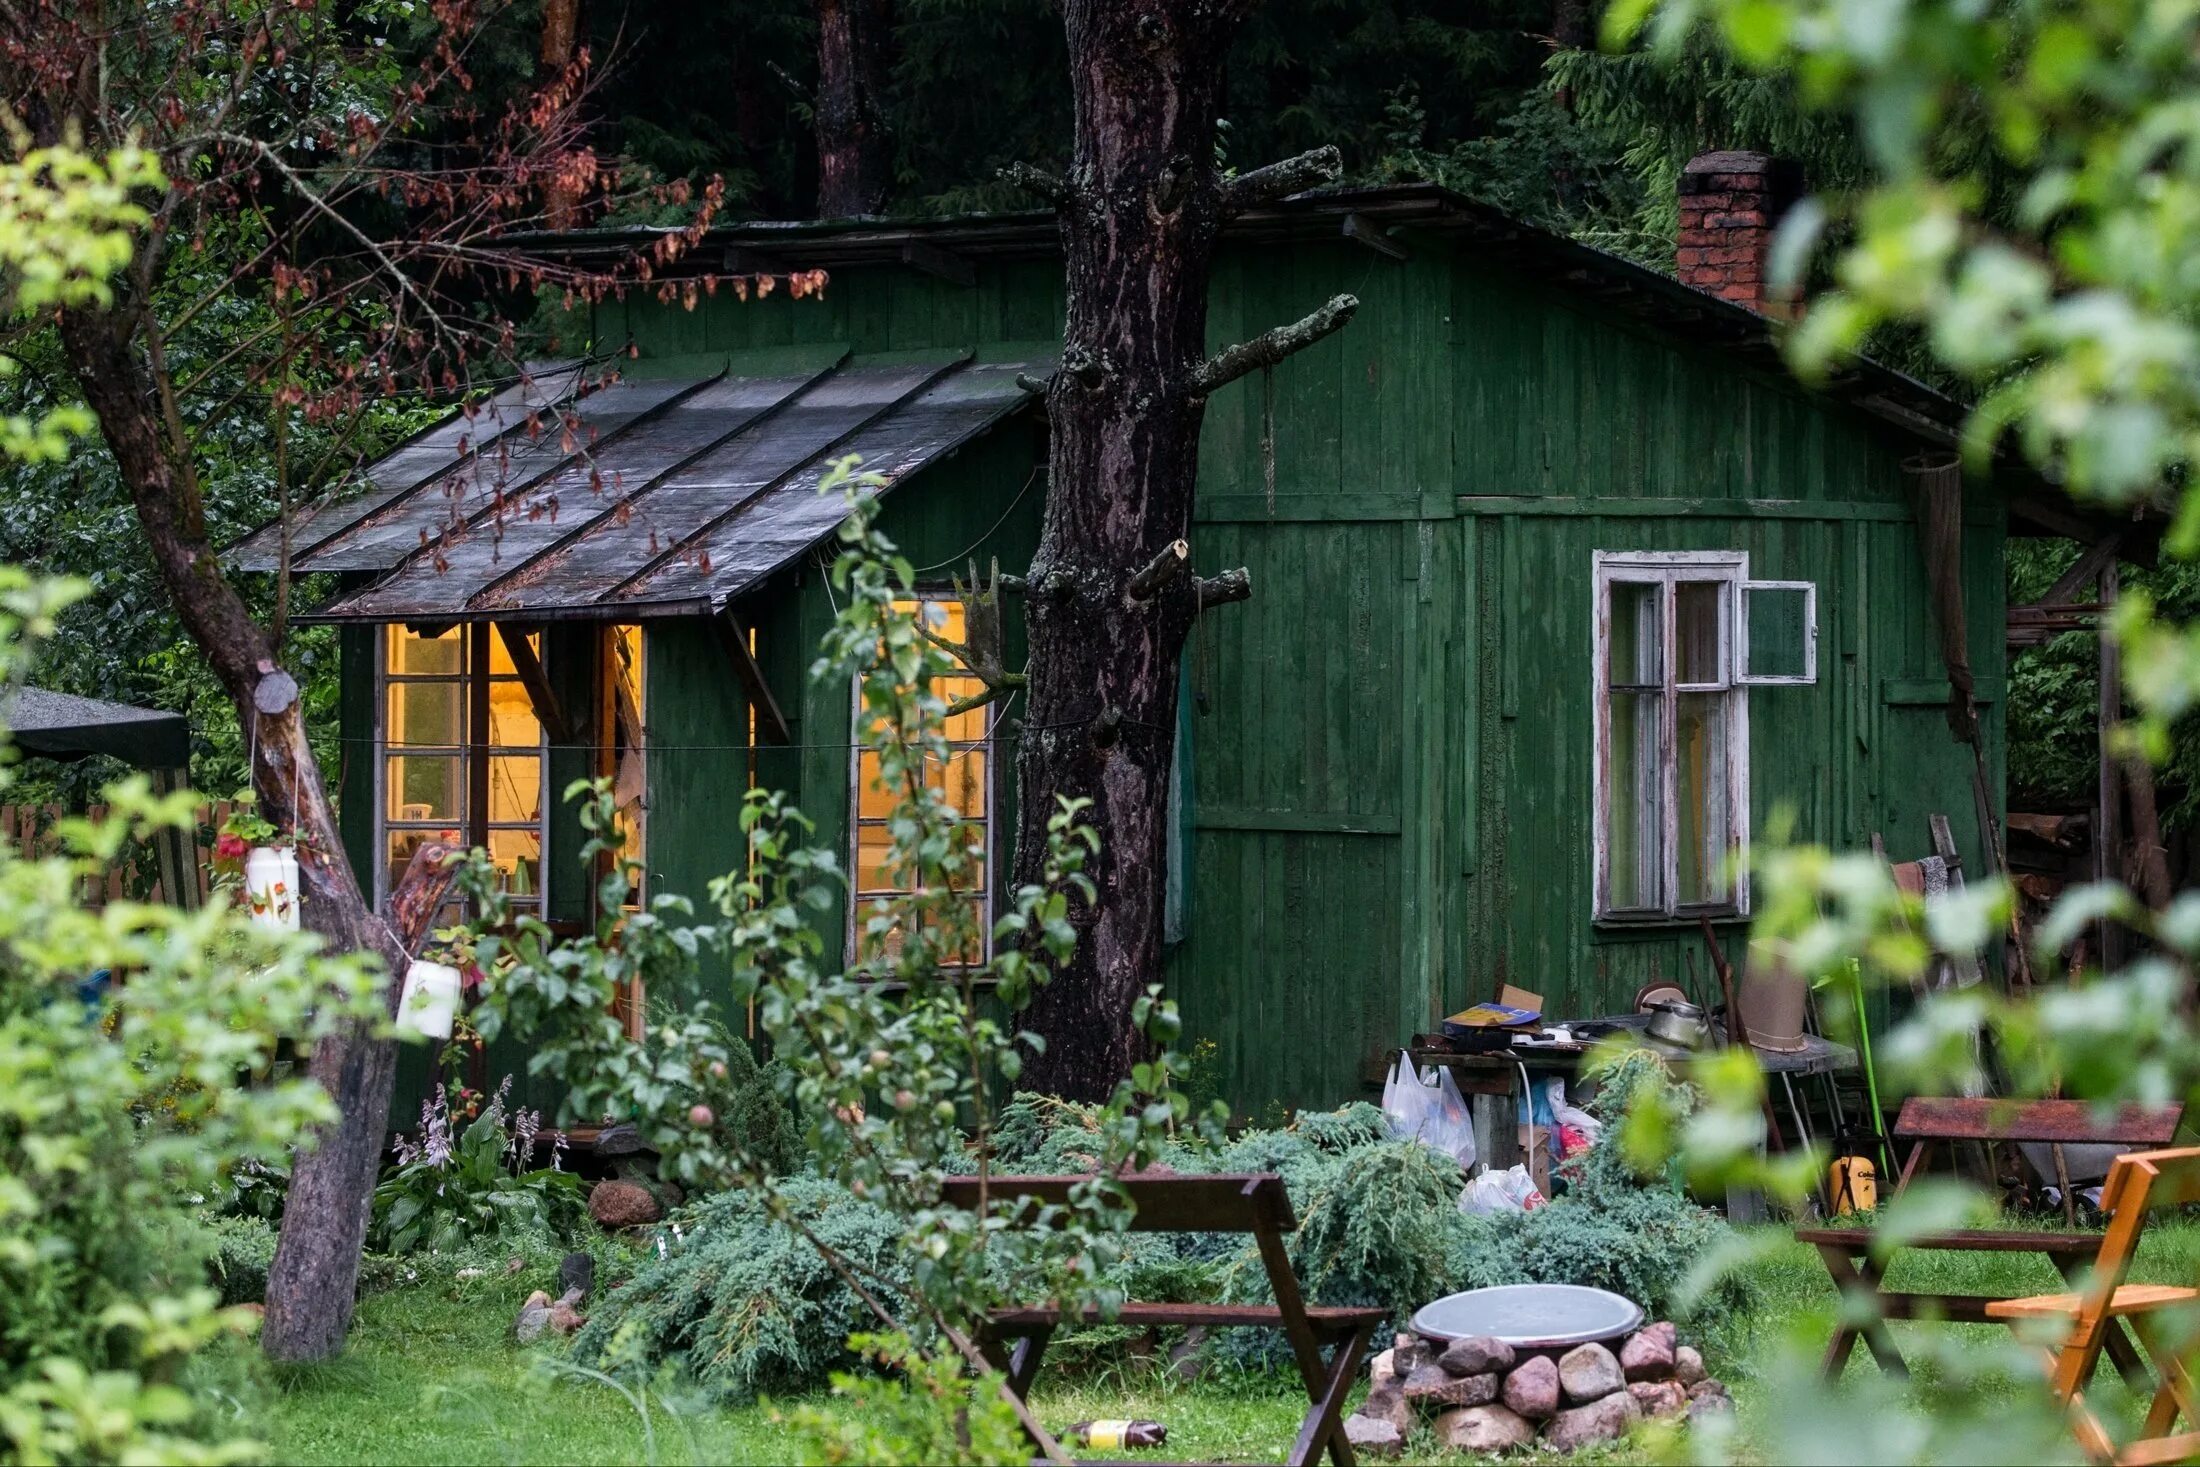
xmin=62 ymin=312 xmax=451 ymax=1359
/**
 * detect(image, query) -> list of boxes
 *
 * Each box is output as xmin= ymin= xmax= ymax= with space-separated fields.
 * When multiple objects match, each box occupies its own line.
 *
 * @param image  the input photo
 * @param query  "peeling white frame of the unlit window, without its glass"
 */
xmin=1591 ymin=550 xmax=1751 ymax=926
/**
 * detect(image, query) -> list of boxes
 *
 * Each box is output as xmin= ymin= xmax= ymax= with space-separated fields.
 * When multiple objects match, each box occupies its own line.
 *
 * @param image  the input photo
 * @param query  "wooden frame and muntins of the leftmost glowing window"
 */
xmin=374 ymin=622 xmax=550 ymax=917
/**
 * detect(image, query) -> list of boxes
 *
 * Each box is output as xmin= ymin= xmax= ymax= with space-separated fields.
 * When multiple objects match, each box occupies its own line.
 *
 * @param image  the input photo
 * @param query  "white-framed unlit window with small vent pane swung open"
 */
xmin=1595 ymin=552 xmax=1817 ymax=922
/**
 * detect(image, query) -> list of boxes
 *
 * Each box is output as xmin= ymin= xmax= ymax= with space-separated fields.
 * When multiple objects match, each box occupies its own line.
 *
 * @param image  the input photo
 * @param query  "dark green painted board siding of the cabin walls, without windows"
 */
xmin=510 ymin=240 xmax=2004 ymax=1111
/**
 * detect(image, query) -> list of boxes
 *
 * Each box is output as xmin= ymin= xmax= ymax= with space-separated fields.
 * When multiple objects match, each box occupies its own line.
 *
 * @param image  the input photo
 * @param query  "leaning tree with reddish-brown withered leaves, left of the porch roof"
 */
xmin=0 ymin=0 xmax=715 ymax=1359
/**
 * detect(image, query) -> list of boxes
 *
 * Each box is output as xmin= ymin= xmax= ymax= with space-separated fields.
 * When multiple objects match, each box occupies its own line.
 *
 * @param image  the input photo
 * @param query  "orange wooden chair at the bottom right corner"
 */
xmin=1987 ymin=1146 xmax=2200 ymax=1465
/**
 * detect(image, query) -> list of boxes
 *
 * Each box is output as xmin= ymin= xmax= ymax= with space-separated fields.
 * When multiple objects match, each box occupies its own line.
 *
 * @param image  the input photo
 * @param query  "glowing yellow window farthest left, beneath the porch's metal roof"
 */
xmin=376 ymin=625 xmax=548 ymax=913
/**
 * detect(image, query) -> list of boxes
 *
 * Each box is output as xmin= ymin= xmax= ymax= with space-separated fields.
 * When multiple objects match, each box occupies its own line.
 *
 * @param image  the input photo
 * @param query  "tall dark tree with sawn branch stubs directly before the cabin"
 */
xmin=1014 ymin=0 xmax=1357 ymax=1098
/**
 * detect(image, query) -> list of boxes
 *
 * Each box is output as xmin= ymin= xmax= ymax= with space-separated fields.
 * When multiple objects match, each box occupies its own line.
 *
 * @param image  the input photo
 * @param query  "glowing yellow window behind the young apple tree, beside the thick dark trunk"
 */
xmin=847 ymin=596 xmax=992 ymax=963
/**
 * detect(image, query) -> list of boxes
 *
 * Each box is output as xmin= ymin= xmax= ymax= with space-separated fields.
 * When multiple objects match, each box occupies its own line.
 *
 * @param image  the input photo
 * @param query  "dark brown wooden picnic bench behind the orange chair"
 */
xmin=1795 ymin=1098 xmax=2185 ymax=1381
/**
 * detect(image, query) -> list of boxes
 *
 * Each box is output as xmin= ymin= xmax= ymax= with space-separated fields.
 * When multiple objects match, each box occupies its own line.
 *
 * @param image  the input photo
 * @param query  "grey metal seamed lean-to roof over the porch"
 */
xmin=231 ymin=348 xmax=1049 ymax=622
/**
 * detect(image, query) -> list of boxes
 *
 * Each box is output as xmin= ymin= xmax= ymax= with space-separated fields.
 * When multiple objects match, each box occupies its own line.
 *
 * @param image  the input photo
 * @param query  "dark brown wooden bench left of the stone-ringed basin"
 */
xmin=944 ymin=1172 xmax=1388 ymax=1467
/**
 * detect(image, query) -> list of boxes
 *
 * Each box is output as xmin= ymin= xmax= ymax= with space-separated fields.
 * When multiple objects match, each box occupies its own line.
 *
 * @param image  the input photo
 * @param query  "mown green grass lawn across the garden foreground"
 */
xmin=257 ymin=1225 xmax=2200 ymax=1467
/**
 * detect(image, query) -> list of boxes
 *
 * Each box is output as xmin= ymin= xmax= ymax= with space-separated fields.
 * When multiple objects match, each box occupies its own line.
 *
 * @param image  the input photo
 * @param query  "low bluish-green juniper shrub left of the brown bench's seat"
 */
xmin=574 ymin=1177 xmax=909 ymax=1401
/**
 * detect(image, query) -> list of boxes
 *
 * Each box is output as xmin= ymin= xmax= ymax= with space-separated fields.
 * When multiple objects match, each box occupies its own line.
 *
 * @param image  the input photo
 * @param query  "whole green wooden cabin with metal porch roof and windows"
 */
xmin=240 ymin=187 xmax=2068 ymax=1117
